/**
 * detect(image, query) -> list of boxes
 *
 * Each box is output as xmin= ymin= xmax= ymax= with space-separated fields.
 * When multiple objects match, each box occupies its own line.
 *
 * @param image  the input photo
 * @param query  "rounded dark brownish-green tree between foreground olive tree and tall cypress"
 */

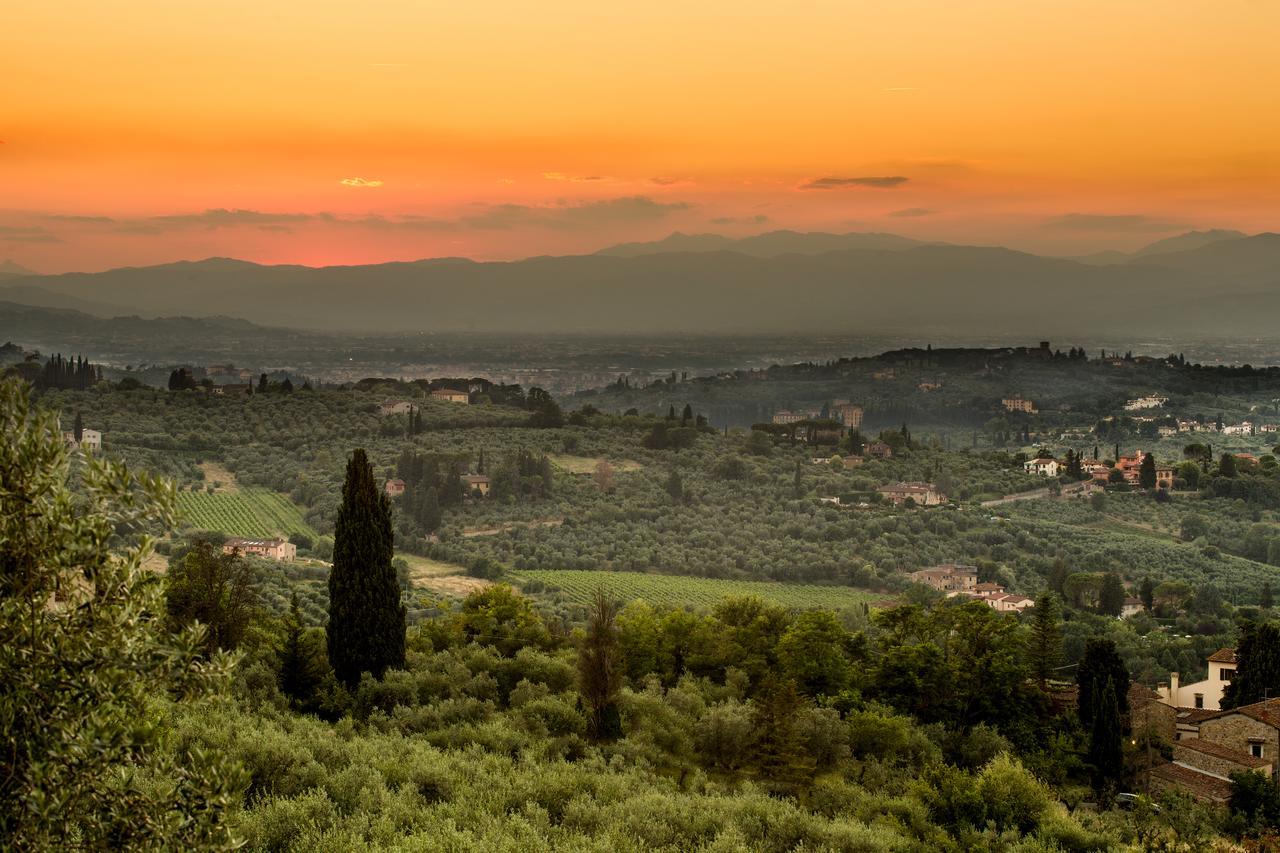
xmin=165 ymin=539 xmax=255 ymax=652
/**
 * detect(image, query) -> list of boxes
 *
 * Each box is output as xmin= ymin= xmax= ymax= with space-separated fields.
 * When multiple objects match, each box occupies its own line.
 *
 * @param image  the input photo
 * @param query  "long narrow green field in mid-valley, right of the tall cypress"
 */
xmin=513 ymin=569 xmax=883 ymax=608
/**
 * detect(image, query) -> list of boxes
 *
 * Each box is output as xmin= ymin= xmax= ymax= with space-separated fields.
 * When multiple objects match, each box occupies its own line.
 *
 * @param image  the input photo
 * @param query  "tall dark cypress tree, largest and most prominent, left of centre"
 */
xmin=328 ymin=448 xmax=404 ymax=688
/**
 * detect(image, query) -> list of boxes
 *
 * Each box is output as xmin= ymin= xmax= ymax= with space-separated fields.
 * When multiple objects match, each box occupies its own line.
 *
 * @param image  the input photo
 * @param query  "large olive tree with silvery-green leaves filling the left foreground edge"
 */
xmin=0 ymin=380 xmax=248 ymax=850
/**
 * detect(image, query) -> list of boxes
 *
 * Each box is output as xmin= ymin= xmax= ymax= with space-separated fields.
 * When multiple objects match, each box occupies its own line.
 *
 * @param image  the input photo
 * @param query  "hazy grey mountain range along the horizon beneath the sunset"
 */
xmin=0 ymin=232 xmax=1280 ymax=337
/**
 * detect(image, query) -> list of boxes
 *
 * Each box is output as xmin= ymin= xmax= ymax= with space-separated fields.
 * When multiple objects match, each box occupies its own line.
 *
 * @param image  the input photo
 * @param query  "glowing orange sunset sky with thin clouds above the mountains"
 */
xmin=0 ymin=0 xmax=1280 ymax=273
